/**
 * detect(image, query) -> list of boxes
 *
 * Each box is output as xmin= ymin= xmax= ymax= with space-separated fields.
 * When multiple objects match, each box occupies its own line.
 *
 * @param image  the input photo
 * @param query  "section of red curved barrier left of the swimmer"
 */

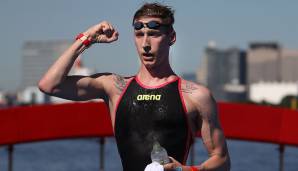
xmin=0 ymin=102 xmax=113 ymax=145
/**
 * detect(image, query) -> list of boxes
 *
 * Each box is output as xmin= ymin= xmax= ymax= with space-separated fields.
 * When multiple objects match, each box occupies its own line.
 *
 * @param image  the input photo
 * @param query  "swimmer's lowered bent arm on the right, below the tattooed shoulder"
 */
xmin=196 ymin=87 xmax=230 ymax=171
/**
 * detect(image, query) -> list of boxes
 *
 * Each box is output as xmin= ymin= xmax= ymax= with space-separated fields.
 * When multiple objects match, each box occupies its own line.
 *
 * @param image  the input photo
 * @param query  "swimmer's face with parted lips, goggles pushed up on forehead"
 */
xmin=134 ymin=17 xmax=176 ymax=68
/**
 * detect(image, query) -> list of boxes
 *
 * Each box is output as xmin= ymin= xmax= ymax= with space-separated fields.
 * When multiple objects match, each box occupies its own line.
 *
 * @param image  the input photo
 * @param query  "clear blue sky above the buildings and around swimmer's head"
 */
xmin=0 ymin=0 xmax=298 ymax=90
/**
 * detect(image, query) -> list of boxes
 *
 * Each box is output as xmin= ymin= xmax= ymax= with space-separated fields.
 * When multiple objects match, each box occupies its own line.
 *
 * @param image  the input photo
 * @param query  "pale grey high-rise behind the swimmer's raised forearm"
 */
xmin=21 ymin=40 xmax=71 ymax=89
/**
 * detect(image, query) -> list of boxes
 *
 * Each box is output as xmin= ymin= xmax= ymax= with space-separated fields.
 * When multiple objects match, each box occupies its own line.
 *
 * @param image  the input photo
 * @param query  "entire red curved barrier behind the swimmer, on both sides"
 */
xmin=0 ymin=102 xmax=298 ymax=146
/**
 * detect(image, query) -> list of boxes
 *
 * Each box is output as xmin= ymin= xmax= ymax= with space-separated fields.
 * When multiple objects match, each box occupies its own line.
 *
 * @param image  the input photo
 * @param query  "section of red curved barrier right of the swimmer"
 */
xmin=219 ymin=103 xmax=298 ymax=146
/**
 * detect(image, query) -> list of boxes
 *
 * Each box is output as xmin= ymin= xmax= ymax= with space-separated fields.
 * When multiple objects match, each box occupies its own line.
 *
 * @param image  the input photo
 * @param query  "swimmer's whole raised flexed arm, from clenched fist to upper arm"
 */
xmin=38 ymin=21 xmax=118 ymax=100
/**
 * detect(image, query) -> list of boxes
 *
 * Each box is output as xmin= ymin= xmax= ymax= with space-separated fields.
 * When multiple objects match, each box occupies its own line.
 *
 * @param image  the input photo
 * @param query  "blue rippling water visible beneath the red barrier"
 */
xmin=0 ymin=138 xmax=298 ymax=171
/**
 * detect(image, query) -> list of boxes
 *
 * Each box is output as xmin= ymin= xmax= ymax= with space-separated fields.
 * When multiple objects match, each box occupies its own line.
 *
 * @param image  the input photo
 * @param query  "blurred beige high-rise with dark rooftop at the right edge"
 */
xmin=247 ymin=42 xmax=298 ymax=84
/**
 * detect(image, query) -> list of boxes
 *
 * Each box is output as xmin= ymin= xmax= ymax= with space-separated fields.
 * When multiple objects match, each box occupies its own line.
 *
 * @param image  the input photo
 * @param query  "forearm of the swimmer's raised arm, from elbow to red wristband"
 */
xmin=38 ymin=40 xmax=86 ymax=94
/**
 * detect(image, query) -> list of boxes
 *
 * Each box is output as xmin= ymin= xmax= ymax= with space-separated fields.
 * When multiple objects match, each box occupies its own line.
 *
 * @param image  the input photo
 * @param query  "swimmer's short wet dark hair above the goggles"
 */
xmin=132 ymin=2 xmax=175 ymax=28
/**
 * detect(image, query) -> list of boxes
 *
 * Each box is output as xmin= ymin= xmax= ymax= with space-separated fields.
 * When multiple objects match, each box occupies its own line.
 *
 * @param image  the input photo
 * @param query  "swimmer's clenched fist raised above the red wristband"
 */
xmin=84 ymin=21 xmax=119 ymax=43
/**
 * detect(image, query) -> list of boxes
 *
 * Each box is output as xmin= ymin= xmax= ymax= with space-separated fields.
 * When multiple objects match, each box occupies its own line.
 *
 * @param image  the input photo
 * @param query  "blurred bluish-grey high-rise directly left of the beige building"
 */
xmin=198 ymin=43 xmax=247 ymax=101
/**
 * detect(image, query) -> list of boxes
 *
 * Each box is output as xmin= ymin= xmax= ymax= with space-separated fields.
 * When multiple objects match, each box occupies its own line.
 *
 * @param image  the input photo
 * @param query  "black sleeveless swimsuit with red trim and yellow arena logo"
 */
xmin=114 ymin=77 xmax=191 ymax=171
